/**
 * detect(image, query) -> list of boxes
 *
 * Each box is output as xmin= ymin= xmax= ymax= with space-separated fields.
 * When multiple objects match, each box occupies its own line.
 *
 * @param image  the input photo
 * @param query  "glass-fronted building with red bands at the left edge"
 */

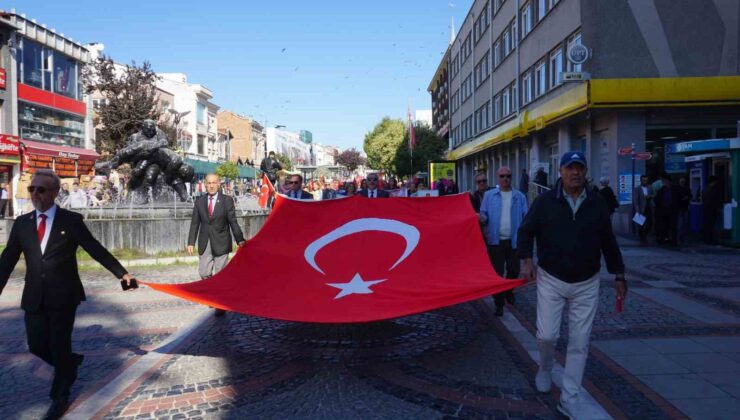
xmin=0 ymin=10 xmax=99 ymax=214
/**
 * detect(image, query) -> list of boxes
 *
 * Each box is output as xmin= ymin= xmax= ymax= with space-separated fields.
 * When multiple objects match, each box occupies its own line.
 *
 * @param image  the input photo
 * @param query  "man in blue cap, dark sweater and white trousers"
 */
xmin=517 ymin=152 xmax=627 ymax=419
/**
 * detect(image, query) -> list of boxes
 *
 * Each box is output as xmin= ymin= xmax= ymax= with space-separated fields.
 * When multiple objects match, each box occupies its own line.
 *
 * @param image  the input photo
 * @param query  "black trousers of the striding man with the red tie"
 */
xmin=25 ymin=305 xmax=77 ymax=399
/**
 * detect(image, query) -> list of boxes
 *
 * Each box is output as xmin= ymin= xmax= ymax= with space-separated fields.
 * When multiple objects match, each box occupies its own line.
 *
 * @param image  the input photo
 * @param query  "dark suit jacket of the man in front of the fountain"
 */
xmin=188 ymin=193 xmax=244 ymax=257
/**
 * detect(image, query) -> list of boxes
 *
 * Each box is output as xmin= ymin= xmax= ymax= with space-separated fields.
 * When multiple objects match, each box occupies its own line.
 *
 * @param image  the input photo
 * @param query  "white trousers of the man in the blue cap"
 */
xmin=537 ymin=268 xmax=599 ymax=402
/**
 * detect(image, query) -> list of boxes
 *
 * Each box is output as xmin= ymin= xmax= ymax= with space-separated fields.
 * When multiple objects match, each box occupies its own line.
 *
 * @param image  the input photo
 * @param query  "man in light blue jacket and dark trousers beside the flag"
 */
xmin=480 ymin=166 xmax=527 ymax=316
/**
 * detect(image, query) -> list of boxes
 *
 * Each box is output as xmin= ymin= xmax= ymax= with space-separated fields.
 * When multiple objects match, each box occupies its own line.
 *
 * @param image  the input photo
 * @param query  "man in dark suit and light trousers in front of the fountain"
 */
xmin=188 ymin=174 xmax=244 ymax=316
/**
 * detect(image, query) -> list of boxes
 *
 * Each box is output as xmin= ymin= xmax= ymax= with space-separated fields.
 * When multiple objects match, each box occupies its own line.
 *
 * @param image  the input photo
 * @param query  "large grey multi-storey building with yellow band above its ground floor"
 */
xmin=432 ymin=0 xmax=740 ymax=236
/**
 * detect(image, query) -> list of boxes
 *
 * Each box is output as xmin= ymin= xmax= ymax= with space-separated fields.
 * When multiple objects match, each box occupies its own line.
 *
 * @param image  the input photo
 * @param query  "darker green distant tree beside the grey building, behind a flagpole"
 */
xmin=394 ymin=124 xmax=447 ymax=175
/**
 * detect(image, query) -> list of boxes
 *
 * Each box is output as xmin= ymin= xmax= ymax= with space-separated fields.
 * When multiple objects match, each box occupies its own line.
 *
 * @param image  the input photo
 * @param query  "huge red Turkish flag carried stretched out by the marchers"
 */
xmin=143 ymin=194 xmax=524 ymax=323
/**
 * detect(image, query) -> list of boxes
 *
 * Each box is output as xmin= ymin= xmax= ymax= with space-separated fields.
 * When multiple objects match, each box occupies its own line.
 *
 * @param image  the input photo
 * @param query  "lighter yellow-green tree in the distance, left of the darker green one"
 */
xmin=364 ymin=117 xmax=406 ymax=173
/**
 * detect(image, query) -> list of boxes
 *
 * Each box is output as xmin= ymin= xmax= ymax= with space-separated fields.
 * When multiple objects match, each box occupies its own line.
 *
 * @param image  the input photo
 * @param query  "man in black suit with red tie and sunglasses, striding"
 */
xmin=0 ymin=169 xmax=134 ymax=419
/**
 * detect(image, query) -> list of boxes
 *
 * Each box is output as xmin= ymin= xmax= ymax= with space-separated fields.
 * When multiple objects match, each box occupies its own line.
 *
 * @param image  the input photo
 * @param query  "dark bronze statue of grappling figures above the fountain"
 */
xmin=95 ymin=120 xmax=195 ymax=201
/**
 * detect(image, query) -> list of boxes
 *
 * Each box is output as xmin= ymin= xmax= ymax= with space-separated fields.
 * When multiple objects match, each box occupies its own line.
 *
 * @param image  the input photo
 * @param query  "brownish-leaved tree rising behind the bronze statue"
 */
xmin=82 ymin=56 xmax=160 ymax=153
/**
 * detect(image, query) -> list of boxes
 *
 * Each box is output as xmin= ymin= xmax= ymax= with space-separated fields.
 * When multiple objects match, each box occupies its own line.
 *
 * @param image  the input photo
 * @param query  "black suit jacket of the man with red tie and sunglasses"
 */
xmin=0 ymin=207 xmax=127 ymax=311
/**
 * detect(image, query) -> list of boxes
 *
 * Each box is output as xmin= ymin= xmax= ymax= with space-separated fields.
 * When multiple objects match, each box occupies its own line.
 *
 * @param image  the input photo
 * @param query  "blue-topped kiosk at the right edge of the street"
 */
xmin=666 ymin=138 xmax=740 ymax=246
